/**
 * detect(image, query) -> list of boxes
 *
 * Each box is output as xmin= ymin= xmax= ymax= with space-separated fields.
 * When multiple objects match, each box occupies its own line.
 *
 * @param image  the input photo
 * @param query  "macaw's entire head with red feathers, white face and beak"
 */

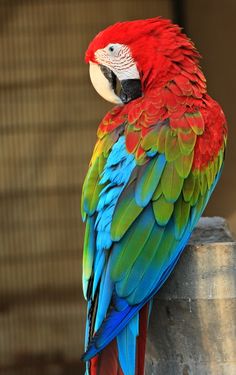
xmin=85 ymin=17 xmax=199 ymax=104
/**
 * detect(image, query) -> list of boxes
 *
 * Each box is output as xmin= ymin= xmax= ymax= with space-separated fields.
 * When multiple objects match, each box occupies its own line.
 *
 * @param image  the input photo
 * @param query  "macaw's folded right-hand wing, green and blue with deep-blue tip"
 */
xmin=84 ymin=106 xmax=224 ymax=360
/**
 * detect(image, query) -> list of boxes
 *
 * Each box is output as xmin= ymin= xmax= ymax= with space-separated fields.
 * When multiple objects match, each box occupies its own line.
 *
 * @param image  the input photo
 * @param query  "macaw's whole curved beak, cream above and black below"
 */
xmin=89 ymin=62 xmax=142 ymax=104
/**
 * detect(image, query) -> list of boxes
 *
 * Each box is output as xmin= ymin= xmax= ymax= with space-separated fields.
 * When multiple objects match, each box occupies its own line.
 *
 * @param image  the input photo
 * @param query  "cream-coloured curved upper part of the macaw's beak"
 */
xmin=89 ymin=62 xmax=122 ymax=104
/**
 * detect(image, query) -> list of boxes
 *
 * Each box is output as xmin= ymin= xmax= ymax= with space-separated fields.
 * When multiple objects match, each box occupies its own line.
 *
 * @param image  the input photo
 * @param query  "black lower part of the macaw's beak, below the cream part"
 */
xmin=100 ymin=65 xmax=142 ymax=104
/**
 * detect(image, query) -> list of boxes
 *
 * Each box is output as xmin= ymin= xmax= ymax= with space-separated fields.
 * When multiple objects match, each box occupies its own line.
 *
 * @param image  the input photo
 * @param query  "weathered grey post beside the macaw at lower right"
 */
xmin=146 ymin=218 xmax=236 ymax=375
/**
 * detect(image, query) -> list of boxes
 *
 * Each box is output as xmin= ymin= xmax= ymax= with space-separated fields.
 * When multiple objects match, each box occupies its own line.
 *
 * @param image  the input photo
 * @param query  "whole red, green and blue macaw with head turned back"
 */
xmin=82 ymin=17 xmax=227 ymax=375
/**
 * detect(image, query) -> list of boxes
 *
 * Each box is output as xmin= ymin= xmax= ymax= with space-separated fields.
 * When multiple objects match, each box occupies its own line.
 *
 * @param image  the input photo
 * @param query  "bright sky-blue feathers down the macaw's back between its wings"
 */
xmin=86 ymin=136 xmax=136 ymax=340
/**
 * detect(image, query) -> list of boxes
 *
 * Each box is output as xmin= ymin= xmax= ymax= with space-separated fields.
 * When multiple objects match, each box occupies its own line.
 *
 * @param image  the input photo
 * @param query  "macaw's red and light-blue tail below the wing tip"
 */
xmin=87 ymin=304 xmax=149 ymax=375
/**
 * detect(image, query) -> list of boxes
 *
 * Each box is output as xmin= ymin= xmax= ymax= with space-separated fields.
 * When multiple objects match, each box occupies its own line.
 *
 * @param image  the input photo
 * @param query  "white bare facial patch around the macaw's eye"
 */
xmin=95 ymin=43 xmax=140 ymax=81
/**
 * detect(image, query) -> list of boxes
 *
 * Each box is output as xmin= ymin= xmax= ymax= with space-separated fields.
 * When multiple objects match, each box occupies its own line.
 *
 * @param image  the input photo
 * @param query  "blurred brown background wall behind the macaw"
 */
xmin=0 ymin=0 xmax=236 ymax=375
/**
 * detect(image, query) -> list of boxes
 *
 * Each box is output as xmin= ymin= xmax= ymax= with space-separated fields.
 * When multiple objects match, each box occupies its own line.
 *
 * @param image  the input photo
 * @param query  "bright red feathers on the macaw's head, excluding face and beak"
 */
xmin=85 ymin=17 xmax=199 ymax=91
